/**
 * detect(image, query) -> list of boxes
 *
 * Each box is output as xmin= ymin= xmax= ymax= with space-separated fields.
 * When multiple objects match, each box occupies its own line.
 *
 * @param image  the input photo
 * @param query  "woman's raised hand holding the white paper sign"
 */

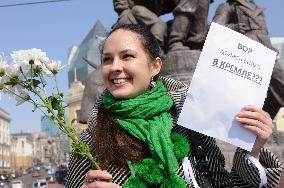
xmin=236 ymin=105 xmax=273 ymax=159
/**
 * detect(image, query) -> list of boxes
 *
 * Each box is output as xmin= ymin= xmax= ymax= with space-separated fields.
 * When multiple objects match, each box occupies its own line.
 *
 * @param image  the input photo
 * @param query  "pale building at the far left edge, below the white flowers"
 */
xmin=0 ymin=108 xmax=11 ymax=174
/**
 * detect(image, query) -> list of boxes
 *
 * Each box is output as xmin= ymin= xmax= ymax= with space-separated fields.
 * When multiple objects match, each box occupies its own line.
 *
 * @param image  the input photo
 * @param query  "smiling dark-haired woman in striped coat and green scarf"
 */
xmin=66 ymin=24 xmax=283 ymax=188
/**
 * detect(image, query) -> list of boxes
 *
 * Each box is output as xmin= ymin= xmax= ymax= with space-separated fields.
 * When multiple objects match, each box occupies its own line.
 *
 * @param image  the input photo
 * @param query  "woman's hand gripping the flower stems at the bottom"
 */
xmin=81 ymin=170 xmax=120 ymax=188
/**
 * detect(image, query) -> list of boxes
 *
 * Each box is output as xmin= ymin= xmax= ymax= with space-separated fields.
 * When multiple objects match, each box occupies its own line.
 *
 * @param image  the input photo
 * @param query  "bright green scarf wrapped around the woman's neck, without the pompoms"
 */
xmin=103 ymin=81 xmax=178 ymax=177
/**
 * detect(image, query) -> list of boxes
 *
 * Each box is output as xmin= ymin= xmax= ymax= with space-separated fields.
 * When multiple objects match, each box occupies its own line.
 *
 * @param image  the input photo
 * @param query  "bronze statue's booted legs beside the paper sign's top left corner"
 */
xmin=168 ymin=0 xmax=213 ymax=51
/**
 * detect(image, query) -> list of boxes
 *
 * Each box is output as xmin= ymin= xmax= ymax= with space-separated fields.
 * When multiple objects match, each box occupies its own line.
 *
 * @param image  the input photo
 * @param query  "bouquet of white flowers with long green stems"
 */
xmin=0 ymin=48 xmax=100 ymax=169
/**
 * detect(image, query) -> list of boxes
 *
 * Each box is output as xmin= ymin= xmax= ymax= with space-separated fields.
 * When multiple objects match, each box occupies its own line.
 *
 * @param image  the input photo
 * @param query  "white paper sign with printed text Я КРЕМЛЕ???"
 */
xmin=178 ymin=23 xmax=276 ymax=151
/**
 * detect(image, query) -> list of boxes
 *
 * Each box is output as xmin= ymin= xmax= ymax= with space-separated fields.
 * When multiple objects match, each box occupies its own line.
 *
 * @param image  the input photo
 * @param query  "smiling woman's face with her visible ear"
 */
xmin=102 ymin=29 xmax=161 ymax=99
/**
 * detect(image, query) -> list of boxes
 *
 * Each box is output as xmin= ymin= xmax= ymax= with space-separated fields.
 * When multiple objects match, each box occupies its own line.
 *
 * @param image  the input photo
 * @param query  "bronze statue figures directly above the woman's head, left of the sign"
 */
xmin=113 ymin=0 xmax=212 ymax=52
